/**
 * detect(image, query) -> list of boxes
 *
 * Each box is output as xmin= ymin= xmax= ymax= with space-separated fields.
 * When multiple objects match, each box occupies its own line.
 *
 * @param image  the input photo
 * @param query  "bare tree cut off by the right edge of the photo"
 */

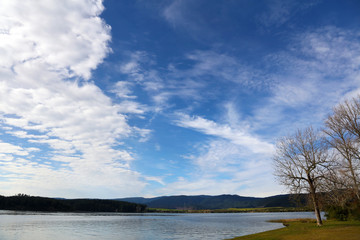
xmin=323 ymin=97 xmax=360 ymax=201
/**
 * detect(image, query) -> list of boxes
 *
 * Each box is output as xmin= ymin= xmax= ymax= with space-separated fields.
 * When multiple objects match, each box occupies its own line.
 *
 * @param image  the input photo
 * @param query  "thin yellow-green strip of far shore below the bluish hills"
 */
xmin=147 ymin=207 xmax=312 ymax=213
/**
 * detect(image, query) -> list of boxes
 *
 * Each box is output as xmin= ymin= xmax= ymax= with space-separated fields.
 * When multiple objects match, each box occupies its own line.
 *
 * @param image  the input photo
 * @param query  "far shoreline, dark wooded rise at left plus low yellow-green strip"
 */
xmin=0 ymin=194 xmax=312 ymax=213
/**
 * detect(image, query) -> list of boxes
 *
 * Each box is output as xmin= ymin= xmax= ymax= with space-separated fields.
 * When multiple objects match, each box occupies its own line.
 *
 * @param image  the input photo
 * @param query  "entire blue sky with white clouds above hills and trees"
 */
xmin=0 ymin=0 xmax=360 ymax=198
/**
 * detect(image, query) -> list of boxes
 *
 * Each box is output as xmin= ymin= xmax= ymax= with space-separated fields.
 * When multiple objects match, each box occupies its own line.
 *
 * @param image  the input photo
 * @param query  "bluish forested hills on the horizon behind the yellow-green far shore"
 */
xmin=117 ymin=194 xmax=305 ymax=210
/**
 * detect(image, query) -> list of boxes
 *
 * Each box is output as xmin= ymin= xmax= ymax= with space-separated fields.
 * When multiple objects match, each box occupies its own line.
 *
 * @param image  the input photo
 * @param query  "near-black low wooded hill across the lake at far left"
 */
xmin=0 ymin=194 xmax=146 ymax=212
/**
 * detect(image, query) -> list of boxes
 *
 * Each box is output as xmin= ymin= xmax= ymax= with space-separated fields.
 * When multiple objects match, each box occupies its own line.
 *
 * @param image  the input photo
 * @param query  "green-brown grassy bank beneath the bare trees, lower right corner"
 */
xmin=228 ymin=220 xmax=360 ymax=240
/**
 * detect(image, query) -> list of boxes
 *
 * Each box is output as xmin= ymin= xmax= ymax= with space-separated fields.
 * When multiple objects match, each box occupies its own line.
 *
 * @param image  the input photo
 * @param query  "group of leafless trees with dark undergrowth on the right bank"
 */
xmin=273 ymin=96 xmax=360 ymax=226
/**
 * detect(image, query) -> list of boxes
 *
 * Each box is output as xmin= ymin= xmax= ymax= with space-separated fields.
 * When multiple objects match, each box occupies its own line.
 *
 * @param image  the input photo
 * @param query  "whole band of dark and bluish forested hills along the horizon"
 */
xmin=0 ymin=194 xmax=305 ymax=212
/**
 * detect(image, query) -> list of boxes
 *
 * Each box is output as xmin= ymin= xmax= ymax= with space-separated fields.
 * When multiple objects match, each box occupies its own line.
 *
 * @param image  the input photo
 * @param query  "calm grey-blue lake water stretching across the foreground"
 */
xmin=0 ymin=211 xmax=314 ymax=240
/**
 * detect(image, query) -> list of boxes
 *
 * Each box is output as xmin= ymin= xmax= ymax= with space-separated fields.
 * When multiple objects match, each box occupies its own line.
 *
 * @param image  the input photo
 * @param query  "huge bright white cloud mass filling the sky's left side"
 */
xmin=0 ymin=0 xmax=150 ymax=197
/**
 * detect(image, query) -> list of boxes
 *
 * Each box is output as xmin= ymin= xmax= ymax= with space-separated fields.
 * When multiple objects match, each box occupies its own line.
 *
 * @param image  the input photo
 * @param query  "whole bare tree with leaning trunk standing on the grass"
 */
xmin=274 ymin=127 xmax=331 ymax=226
